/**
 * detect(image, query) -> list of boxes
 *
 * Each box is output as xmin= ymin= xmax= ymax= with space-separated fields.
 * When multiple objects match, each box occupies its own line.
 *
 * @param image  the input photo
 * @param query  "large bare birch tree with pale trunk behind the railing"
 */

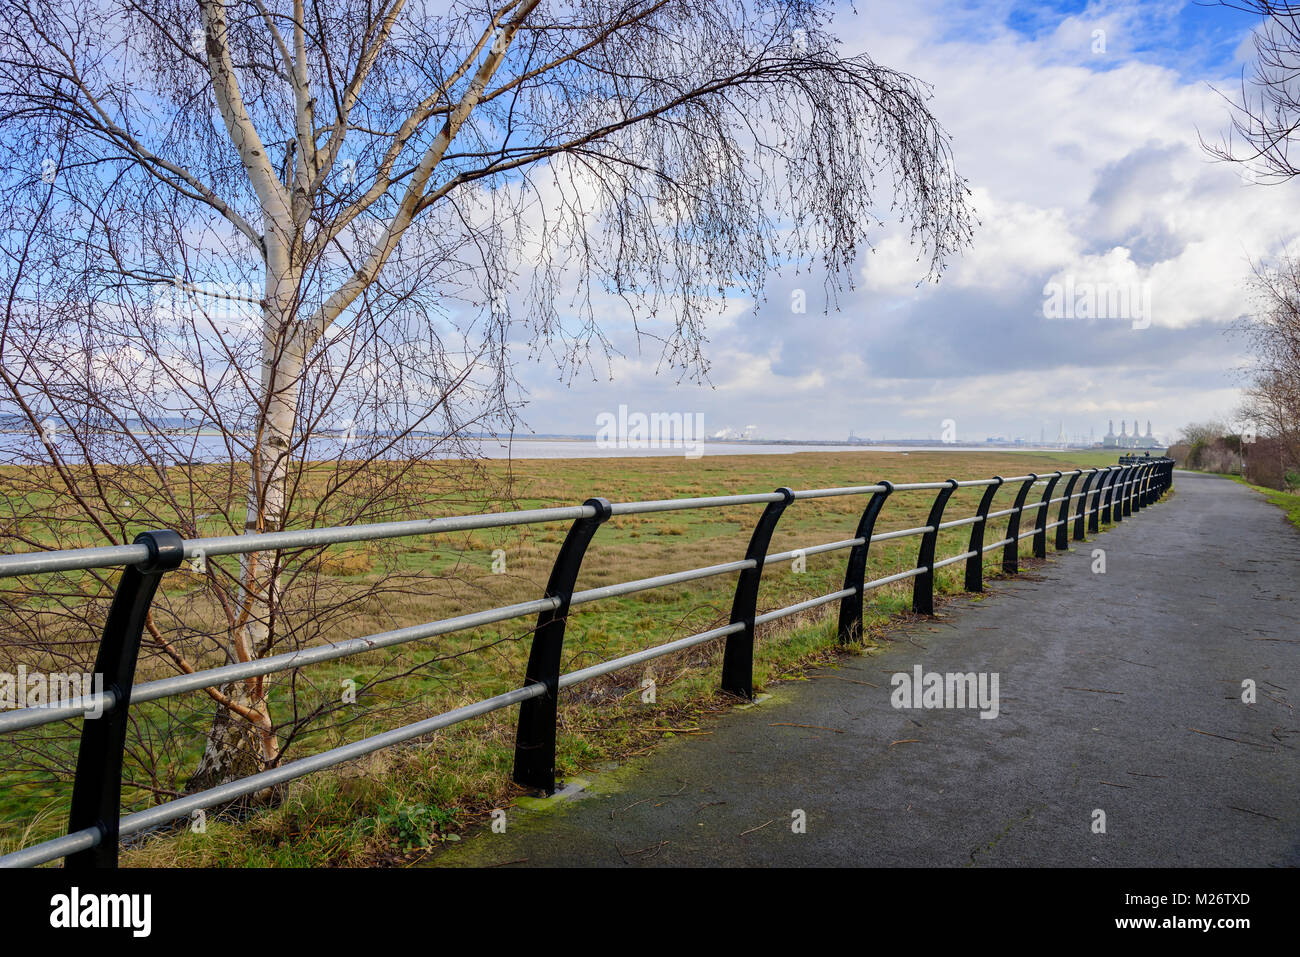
xmin=0 ymin=0 xmax=974 ymax=785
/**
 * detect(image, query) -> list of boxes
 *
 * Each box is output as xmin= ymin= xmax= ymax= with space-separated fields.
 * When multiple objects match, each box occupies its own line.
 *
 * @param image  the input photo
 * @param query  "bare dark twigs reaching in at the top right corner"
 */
xmin=1201 ymin=0 xmax=1300 ymax=183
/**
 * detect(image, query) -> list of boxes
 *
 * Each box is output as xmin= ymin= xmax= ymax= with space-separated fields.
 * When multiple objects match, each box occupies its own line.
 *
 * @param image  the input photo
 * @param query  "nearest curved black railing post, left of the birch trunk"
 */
xmin=64 ymin=529 xmax=185 ymax=870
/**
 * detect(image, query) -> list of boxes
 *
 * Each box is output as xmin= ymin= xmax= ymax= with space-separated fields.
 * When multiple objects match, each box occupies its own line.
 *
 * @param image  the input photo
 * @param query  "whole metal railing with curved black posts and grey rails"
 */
xmin=0 ymin=458 xmax=1174 ymax=867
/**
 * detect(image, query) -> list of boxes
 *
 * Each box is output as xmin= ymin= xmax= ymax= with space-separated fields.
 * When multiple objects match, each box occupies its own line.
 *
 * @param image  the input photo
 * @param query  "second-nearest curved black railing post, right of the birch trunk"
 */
xmin=512 ymin=498 xmax=611 ymax=794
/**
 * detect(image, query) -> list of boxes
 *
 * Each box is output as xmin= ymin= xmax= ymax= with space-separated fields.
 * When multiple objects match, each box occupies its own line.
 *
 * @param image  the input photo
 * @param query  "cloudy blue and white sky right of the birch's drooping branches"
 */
xmin=501 ymin=0 xmax=1300 ymax=443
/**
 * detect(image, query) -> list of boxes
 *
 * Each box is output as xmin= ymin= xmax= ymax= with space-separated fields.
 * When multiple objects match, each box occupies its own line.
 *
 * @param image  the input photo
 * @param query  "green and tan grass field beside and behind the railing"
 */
xmin=0 ymin=451 xmax=1138 ymax=866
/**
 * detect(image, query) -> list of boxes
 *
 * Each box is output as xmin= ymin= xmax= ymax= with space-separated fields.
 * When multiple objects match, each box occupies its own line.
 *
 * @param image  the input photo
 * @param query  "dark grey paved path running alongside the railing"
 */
xmin=436 ymin=473 xmax=1300 ymax=866
